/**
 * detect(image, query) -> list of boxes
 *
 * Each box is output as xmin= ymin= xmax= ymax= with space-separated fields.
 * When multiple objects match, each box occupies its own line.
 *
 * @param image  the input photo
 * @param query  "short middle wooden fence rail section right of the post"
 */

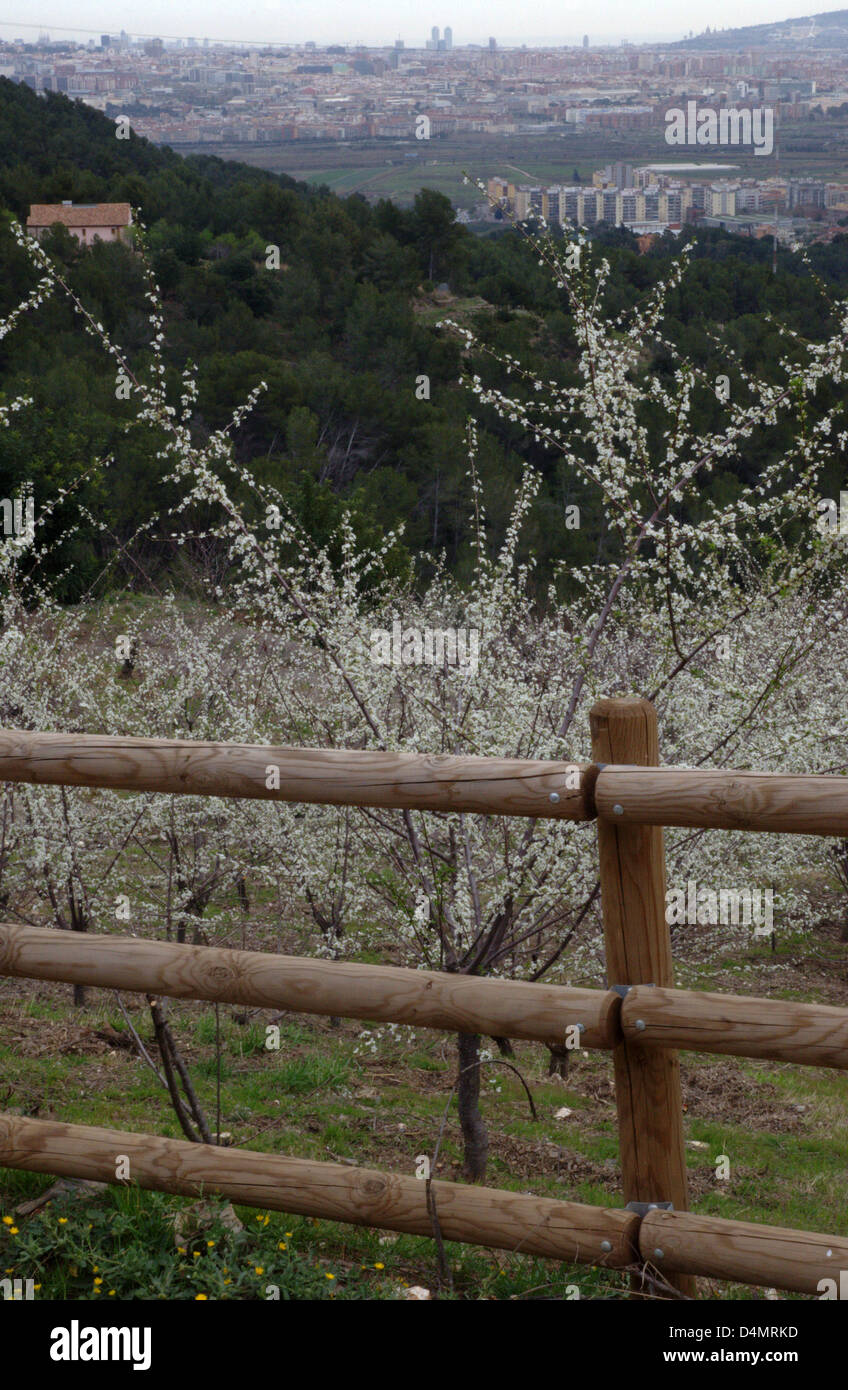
xmin=621 ymin=984 xmax=848 ymax=1070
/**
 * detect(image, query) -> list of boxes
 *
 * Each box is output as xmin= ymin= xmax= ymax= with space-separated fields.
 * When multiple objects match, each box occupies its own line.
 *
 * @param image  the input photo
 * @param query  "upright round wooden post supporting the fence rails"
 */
xmin=589 ymin=699 xmax=695 ymax=1297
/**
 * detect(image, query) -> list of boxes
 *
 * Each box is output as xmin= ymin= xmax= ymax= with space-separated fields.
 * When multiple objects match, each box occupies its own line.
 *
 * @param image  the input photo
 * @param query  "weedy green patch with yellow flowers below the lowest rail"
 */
xmin=0 ymin=1173 xmax=624 ymax=1302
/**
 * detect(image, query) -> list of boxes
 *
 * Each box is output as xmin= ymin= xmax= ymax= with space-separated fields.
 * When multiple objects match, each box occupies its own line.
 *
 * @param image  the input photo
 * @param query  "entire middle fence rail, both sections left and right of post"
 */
xmin=8 ymin=923 xmax=848 ymax=1070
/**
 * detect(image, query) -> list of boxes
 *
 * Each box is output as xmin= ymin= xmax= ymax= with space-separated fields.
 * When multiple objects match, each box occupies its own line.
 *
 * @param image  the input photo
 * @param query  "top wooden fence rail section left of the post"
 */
xmin=0 ymin=728 xmax=595 ymax=820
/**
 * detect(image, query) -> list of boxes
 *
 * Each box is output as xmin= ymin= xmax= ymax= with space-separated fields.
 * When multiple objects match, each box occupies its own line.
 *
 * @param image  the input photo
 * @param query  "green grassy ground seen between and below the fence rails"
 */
xmin=0 ymin=911 xmax=848 ymax=1300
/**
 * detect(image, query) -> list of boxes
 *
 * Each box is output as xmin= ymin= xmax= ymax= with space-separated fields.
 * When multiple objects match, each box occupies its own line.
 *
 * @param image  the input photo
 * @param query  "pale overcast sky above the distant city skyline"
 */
xmin=0 ymin=0 xmax=848 ymax=47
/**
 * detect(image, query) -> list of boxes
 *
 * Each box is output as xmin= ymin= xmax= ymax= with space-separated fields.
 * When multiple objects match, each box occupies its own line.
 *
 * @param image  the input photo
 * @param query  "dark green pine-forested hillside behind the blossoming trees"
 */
xmin=0 ymin=79 xmax=848 ymax=596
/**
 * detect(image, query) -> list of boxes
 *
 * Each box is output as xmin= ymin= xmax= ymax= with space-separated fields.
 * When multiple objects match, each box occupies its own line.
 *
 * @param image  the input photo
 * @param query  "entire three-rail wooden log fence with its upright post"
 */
xmin=0 ymin=699 xmax=848 ymax=1297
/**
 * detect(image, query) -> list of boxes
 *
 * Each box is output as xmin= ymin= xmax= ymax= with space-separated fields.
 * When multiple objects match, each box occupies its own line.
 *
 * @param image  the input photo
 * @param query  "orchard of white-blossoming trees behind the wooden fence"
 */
xmin=0 ymin=211 xmax=848 ymax=1179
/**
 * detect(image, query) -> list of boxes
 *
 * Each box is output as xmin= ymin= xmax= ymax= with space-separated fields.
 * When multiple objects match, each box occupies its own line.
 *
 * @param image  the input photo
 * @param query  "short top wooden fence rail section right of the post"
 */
xmin=595 ymin=763 xmax=848 ymax=835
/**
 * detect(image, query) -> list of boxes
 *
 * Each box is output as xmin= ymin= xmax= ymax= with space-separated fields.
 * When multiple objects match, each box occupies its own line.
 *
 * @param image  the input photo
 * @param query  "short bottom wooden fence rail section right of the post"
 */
xmin=639 ymin=1212 xmax=848 ymax=1295
